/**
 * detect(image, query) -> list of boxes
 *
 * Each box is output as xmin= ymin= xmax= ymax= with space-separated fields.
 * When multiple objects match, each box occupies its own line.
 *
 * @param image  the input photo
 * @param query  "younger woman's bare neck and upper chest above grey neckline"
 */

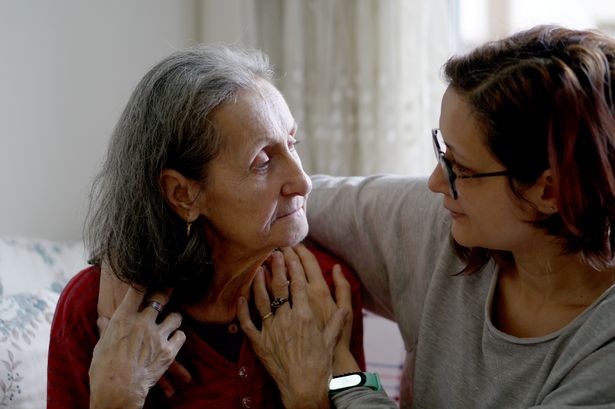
xmin=493 ymin=237 xmax=615 ymax=337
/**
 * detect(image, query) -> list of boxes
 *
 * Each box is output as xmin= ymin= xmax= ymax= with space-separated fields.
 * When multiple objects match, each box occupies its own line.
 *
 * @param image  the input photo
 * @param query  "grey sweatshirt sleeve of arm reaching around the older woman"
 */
xmin=307 ymin=175 xmax=451 ymax=350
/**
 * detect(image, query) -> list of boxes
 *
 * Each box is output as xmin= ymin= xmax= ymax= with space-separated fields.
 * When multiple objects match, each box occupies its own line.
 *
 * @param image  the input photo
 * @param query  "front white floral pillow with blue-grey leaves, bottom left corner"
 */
xmin=0 ymin=289 xmax=59 ymax=409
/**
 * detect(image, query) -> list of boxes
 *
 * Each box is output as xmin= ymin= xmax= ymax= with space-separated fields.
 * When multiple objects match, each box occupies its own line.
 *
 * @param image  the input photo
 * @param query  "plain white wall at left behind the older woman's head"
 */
xmin=0 ymin=0 xmax=200 ymax=239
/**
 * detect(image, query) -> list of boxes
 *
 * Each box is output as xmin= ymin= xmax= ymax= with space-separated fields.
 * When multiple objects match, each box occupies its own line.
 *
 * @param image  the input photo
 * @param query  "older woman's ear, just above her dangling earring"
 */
xmin=160 ymin=169 xmax=201 ymax=223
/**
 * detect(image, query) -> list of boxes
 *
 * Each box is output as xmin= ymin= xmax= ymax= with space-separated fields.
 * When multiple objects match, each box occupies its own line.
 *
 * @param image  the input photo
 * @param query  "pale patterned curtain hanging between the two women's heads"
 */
xmin=202 ymin=0 xmax=456 ymax=175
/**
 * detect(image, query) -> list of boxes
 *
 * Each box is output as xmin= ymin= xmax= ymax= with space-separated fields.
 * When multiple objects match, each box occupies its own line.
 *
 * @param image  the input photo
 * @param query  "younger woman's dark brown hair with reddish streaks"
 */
xmin=444 ymin=26 xmax=615 ymax=272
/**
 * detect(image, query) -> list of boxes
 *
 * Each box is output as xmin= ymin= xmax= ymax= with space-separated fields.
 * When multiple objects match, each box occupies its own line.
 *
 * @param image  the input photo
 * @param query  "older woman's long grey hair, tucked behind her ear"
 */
xmin=84 ymin=45 xmax=273 ymax=301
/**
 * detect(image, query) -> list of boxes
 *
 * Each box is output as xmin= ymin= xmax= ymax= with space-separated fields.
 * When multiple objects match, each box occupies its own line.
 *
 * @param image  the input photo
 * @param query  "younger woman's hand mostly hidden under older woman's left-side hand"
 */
xmin=97 ymin=261 xmax=192 ymax=397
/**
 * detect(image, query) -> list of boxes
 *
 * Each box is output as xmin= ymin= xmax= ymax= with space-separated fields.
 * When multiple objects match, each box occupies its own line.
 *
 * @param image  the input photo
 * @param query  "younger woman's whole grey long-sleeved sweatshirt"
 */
xmin=308 ymin=175 xmax=615 ymax=409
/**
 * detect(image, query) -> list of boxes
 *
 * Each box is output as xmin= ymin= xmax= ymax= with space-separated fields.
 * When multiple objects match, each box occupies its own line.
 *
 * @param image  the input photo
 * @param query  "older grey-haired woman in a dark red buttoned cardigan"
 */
xmin=47 ymin=47 xmax=363 ymax=409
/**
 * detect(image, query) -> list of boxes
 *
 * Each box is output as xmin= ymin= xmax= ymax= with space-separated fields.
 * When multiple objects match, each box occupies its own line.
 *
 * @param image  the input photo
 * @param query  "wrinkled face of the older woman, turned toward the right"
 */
xmin=198 ymin=80 xmax=312 ymax=251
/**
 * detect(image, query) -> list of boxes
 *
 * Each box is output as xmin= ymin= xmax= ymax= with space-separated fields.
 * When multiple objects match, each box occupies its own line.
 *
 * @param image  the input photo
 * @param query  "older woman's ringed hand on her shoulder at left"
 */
xmin=89 ymin=287 xmax=186 ymax=409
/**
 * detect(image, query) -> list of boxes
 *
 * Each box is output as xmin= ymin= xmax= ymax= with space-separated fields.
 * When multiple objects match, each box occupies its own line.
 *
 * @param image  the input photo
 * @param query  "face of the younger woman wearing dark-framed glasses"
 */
xmin=429 ymin=87 xmax=536 ymax=251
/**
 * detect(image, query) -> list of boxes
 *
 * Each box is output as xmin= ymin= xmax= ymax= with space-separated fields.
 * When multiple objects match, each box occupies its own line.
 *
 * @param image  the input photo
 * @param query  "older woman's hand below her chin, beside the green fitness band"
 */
xmin=238 ymin=248 xmax=352 ymax=408
